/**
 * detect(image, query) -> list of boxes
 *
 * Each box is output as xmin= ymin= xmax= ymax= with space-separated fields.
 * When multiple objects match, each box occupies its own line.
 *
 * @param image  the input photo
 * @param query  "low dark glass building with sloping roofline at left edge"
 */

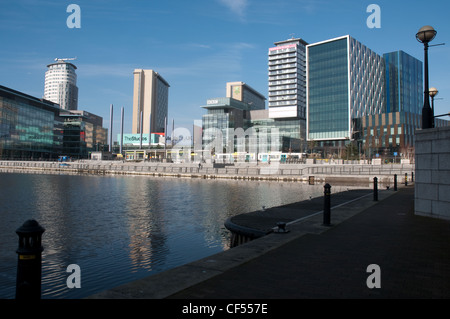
xmin=0 ymin=86 xmax=64 ymax=160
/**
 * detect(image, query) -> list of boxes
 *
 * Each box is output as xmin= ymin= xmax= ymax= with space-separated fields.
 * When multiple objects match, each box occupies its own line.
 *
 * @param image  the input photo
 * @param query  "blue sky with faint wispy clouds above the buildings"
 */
xmin=0 ymin=0 xmax=450 ymax=139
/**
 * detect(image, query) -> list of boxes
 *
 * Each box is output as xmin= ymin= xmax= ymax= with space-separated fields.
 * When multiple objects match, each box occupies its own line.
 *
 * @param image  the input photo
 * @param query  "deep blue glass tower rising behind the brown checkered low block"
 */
xmin=383 ymin=51 xmax=423 ymax=114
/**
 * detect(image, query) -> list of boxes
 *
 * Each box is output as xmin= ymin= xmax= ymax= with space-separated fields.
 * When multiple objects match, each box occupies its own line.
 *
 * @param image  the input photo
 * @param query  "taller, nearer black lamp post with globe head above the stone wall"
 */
xmin=416 ymin=25 xmax=437 ymax=129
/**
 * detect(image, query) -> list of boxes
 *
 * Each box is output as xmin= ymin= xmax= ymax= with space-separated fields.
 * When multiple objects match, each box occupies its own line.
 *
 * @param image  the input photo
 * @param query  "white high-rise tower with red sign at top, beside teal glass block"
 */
xmin=268 ymin=38 xmax=308 ymax=119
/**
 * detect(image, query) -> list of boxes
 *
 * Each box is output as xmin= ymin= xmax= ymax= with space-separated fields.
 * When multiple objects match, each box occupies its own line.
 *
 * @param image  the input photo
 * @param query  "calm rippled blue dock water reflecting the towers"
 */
xmin=0 ymin=173 xmax=356 ymax=298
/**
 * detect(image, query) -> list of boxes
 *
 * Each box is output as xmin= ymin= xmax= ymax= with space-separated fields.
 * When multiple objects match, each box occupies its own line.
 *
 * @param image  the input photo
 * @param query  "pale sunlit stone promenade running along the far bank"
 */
xmin=0 ymin=160 xmax=414 ymax=184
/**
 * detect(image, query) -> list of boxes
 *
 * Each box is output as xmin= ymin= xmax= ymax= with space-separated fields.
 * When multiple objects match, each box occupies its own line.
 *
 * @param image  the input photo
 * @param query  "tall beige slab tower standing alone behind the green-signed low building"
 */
xmin=132 ymin=69 xmax=170 ymax=134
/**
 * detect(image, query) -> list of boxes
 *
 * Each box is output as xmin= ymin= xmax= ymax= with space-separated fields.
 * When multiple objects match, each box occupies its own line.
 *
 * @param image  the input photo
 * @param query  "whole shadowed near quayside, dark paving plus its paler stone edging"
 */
xmin=89 ymin=185 xmax=450 ymax=303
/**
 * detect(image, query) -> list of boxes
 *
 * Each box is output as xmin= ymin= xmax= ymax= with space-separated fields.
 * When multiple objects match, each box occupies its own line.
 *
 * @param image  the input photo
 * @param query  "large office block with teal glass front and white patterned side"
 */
xmin=306 ymin=35 xmax=386 ymax=146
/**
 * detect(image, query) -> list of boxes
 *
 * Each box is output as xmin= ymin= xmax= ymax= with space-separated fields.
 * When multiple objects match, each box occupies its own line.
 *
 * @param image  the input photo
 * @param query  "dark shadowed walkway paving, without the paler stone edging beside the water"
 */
xmin=170 ymin=187 xmax=450 ymax=299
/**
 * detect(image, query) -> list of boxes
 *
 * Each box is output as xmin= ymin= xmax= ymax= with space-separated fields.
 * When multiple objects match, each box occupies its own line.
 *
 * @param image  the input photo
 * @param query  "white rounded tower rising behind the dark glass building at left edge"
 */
xmin=44 ymin=58 xmax=78 ymax=110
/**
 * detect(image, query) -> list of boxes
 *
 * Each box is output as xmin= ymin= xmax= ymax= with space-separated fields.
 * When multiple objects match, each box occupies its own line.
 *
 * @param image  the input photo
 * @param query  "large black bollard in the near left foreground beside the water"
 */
xmin=16 ymin=219 xmax=45 ymax=299
